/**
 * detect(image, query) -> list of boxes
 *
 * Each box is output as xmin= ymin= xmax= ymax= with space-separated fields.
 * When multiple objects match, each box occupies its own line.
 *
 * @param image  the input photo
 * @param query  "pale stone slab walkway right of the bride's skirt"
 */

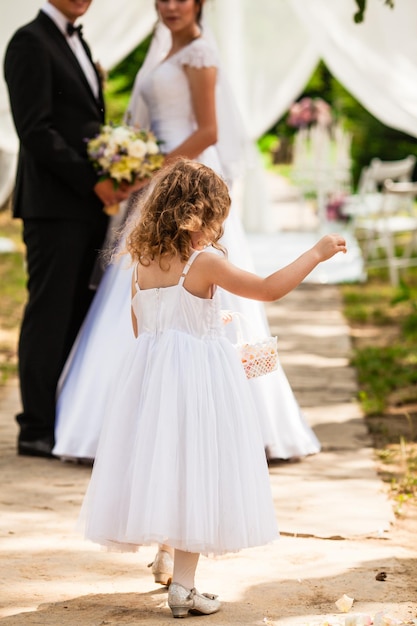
xmin=267 ymin=284 xmax=393 ymax=538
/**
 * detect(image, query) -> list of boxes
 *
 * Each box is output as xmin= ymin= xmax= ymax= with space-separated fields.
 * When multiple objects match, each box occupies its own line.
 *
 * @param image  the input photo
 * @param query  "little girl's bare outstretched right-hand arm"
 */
xmin=197 ymin=234 xmax=347 ymax=302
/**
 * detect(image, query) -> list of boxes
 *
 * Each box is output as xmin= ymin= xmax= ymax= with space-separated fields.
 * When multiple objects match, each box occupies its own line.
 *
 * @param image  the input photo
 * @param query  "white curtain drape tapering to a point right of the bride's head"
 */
xmin=205 ymin=0 xmax=319 ymax=139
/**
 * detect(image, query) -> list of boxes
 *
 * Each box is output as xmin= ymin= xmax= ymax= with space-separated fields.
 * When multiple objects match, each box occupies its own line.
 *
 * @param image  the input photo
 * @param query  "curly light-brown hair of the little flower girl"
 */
xmin=126 ymin=158 xmax=230 ymax=269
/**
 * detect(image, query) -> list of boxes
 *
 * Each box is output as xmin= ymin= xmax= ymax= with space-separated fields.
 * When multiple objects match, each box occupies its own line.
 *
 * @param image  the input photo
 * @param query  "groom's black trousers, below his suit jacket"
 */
xmin=16 ymin=214 xmax=107 ymax=441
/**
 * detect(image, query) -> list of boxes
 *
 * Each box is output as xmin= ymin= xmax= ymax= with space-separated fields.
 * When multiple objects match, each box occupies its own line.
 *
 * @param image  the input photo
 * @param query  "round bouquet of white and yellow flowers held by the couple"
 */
xmin=87 ymin=124 xmax=164 ymax=215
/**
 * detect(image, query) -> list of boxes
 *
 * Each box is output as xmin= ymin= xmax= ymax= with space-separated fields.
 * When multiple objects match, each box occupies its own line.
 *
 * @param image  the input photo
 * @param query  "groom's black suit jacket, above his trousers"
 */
xmin=4 ymin=11 xmax=104 ymax=222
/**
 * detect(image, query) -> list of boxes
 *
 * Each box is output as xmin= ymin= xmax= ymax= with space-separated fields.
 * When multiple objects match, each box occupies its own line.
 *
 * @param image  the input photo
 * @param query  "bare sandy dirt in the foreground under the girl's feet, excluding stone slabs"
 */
xmin=0 ymin=376 xmax=417 ymax=626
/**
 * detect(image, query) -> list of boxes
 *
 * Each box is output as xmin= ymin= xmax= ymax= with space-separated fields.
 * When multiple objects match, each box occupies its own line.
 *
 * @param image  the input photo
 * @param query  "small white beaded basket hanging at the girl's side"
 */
xmin=232 ymin=313 xmax=278 ymax=378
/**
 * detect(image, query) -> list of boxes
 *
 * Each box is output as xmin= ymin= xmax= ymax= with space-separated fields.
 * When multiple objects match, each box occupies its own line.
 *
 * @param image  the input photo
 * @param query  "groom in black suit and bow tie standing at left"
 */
xmin=4 ymin=0 xmax=128 ymax=457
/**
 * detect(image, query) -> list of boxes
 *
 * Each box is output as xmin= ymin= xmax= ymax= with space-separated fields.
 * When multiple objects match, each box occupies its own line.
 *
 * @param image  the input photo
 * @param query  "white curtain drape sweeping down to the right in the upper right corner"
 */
xmin=290 ymin=0 xmax=417 ymax=137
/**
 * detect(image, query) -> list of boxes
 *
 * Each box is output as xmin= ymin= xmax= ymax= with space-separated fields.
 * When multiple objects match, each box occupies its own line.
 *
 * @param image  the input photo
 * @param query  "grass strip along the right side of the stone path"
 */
xmin=341 ymin=268 xmax=417 ymax=515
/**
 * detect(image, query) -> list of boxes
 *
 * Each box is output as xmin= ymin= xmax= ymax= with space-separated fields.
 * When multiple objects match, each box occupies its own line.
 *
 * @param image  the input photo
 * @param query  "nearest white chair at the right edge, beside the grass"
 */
xmin=356 ymin=179 xmax=417 ymax=286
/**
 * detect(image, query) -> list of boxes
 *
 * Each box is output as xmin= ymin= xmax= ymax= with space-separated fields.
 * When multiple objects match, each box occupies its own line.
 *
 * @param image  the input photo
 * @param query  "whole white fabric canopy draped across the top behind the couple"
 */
xmin=0 ymin=0 xmax=417 ymax=219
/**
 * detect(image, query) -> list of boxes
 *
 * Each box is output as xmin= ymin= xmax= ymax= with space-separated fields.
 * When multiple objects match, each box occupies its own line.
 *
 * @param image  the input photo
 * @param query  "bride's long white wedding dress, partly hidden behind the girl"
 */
xmin=53 ymin=38 xmax=320 ymax=459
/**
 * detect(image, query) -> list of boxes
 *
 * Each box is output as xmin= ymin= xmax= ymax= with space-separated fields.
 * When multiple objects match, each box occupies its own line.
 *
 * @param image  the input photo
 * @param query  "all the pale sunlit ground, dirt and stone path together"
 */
xmin=0 ymin=286 xmax=417 ymax=626
